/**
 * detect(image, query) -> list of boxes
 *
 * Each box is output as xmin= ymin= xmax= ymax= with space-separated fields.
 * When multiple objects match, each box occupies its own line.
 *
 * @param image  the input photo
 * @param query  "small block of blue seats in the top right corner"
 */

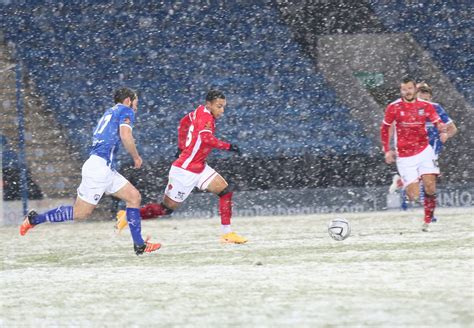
xmin=369 ymin=0 xmax=474 ymax=104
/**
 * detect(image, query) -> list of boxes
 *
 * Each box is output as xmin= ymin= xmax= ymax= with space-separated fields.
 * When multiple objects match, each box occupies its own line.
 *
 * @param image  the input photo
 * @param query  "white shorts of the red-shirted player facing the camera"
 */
xmin=397 ymin=145 xmax=439 ymax=187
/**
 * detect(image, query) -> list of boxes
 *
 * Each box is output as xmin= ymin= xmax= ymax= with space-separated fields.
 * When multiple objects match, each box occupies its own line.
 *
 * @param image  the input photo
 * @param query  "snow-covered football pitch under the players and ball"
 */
xmin=0 ymin=208 xmax=474 ymax=327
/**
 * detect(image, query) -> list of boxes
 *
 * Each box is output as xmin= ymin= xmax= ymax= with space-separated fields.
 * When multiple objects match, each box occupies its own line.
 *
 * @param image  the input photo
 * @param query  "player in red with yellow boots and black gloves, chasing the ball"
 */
xmin=117 ymin=90 xmax=247 ymax=244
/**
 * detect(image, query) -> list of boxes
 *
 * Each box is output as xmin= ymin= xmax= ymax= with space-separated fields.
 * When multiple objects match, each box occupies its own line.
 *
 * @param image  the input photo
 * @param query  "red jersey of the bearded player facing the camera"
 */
xmin=381 ymin=98 xmax=441 ymax=157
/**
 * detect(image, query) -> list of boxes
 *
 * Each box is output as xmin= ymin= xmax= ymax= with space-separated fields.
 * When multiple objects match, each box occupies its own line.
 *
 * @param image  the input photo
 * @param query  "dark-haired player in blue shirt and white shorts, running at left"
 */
xmin=20 ymin=88 xmax=161 ymax=255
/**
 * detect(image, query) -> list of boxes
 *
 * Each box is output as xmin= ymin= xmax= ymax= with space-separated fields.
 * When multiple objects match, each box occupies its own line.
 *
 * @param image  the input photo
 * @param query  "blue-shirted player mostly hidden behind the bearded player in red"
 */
xmin=389 ymin=82 xmax=457 ymax=217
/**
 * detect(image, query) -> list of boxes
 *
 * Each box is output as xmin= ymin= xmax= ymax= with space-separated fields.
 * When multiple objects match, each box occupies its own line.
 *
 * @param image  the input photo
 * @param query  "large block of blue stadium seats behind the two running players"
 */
xmin=0 ymin=0 xmax=372 ymax=165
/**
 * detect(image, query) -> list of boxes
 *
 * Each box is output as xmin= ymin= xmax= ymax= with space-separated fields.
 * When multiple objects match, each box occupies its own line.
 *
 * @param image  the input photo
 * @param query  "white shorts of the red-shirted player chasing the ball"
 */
xmin=165 ymin=164 xmax=218 ymax=203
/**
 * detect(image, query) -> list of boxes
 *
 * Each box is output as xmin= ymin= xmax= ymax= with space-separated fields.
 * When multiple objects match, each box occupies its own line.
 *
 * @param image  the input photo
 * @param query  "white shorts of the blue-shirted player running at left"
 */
xmin=77 ymin=155 xmax=128 ymax=205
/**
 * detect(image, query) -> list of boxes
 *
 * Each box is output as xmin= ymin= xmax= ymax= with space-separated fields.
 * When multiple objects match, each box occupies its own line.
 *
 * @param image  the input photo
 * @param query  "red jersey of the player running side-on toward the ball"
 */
xmin=173 ymin=105 xmax=230 ymax=173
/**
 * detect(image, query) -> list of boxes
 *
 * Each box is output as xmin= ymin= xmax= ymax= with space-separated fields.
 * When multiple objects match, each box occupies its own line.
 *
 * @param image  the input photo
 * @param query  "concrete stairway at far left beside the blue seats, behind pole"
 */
xmin=0 ymin=44 xmax=82 ymax=198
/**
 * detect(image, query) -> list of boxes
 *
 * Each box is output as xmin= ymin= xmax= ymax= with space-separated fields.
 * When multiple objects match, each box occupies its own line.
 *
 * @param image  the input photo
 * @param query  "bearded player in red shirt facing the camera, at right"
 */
xmin=380 ymin=79 xmax=446 ymax=231
